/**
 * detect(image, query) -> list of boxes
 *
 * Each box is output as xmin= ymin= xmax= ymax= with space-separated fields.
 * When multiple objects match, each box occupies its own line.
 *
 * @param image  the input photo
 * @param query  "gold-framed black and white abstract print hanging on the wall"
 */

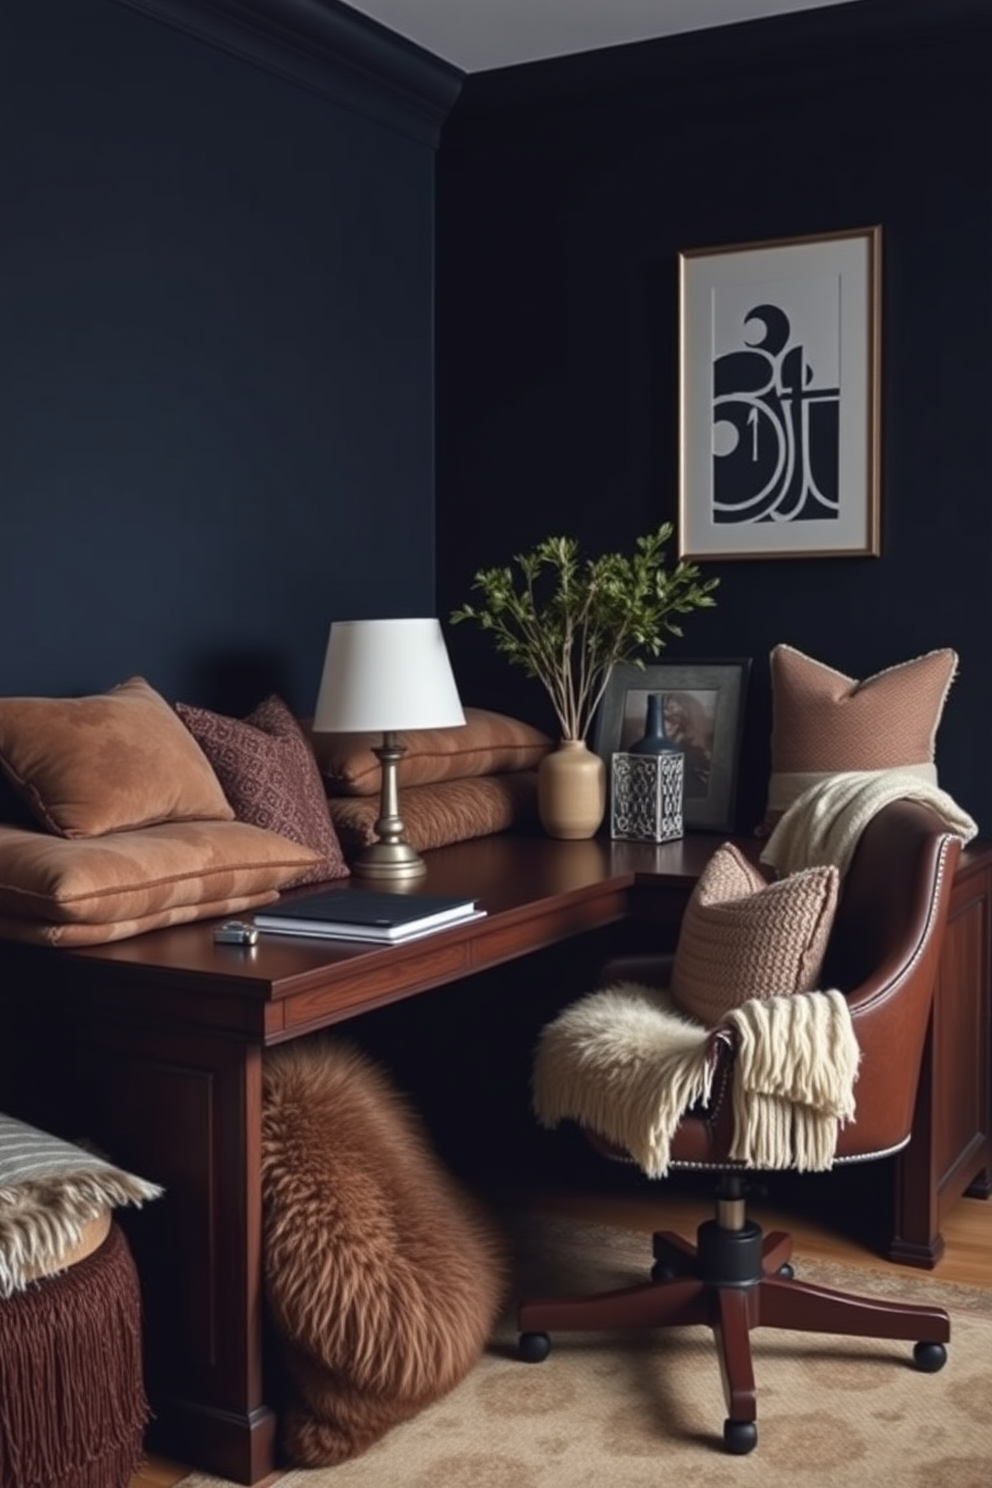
xmin=678 ymin=226 xmax=882 ymax=558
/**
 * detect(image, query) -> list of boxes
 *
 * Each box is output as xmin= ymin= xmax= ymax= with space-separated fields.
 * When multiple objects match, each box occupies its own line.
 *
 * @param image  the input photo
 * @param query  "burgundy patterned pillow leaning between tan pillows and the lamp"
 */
xmin=175 ymin=693 xmax=350 ymax=884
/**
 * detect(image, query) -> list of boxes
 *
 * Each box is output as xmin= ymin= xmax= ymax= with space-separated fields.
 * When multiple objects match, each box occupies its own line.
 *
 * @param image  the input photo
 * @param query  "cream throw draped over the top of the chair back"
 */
xmin=761 ymin=769 xmax=979 ymax=878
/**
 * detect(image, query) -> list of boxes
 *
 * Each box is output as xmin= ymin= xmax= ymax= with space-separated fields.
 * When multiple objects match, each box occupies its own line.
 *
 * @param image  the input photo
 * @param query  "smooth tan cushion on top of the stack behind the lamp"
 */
xmin=309 ymin=708 xmax=553 ymax=796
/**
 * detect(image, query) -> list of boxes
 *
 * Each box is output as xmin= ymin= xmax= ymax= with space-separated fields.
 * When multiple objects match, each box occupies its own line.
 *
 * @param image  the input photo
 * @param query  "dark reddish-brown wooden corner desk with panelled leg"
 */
xmin=0 ymin=835 xmax=992 ymax=1484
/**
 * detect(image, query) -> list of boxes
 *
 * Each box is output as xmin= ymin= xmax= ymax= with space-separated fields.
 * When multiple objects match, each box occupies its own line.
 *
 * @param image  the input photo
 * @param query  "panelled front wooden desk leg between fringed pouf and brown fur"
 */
xmin=72 ymin=1028 xmax=275 ymax=1484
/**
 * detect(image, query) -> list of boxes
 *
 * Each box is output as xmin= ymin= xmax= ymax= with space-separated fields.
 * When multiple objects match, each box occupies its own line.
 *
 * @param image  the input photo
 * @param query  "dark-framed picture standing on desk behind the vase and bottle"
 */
xmin=592 ymin=656 xmax=751 ymax=832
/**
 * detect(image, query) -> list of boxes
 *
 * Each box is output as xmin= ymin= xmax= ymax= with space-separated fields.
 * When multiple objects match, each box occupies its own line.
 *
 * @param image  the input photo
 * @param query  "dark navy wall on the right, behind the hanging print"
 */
xmin=437 ymin=0 xmax=992 ymax=835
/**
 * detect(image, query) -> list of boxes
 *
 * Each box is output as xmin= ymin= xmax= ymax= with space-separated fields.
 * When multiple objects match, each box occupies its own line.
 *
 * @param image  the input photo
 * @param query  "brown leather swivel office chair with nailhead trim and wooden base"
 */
xmin=518 ymin=801 xmax=961 ymax=1454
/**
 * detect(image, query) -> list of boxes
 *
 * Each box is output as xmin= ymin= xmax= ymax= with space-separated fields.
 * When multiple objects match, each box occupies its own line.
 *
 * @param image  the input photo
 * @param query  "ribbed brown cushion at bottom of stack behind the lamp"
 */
xmin=327 ymin=769 xmax=537 ymax=854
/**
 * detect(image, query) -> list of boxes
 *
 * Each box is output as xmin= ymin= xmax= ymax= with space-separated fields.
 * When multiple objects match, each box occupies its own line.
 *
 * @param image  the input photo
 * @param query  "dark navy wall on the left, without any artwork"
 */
xmin=0 ymin=0 xmax=446 ymax=711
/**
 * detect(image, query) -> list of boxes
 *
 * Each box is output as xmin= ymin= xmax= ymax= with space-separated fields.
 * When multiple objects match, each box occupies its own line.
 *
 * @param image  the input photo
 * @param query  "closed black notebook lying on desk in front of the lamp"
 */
xmin=254 ymin=888 xmax=485 ymax=943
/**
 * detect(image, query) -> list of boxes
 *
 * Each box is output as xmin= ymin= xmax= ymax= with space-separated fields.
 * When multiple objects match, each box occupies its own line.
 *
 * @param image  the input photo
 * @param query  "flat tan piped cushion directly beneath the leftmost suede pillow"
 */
xmin=0 ymin=821 xmax=320 ymax=926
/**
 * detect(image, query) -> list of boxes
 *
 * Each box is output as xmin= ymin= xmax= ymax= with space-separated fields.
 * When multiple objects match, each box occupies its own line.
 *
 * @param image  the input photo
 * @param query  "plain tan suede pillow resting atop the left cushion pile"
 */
xmin=0 ymin=677 xmax=233 ymax=838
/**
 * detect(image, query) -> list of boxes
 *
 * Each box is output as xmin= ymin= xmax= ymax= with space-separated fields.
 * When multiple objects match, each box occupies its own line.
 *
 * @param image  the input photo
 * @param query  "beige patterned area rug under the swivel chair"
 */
xmin=180 ymin=1217 xmax=992 ymax=1488
